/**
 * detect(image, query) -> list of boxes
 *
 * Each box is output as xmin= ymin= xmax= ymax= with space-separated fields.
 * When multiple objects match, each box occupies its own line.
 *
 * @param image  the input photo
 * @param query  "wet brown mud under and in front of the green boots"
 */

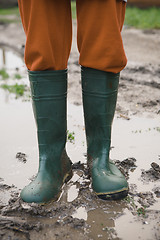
xmin=0 ymin=159 xmax=160 ymax=239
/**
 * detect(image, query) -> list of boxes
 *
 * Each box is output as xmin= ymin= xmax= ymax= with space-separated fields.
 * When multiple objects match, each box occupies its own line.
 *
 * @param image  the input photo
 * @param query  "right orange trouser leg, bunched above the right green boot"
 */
xmin=77 ymin=0 xmax=127 ymax=73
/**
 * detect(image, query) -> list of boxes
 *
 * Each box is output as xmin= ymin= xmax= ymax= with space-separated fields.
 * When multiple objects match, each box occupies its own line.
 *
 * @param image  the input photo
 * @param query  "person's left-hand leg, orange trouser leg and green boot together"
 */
xmin=19 ymin=0 xmax=72 ymax=203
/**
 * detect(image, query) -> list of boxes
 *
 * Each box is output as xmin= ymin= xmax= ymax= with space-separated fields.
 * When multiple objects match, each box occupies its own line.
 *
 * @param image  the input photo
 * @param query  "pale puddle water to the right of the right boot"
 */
xmin=111 ymin=117 xmax=160 ymax=196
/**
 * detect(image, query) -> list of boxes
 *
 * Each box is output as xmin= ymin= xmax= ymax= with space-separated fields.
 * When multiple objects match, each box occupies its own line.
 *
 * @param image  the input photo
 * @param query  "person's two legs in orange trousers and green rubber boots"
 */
xmin=18 ymin=0 xmax=128 ymax=203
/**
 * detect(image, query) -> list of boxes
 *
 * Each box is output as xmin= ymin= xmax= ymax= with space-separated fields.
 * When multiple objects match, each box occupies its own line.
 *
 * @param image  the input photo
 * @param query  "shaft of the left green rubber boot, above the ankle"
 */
xmin=29 ymin=70 xmax=67 ymax=148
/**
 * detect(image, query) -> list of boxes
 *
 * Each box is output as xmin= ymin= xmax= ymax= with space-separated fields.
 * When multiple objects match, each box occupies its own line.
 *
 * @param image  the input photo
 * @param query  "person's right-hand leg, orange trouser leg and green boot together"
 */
xmin=77 ymin=0 xmax=128 ymax=199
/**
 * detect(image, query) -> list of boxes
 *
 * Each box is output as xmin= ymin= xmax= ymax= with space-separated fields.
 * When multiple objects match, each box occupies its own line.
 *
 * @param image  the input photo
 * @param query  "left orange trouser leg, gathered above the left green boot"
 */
xmin=18 ymin=0 xmax=72 ymax=71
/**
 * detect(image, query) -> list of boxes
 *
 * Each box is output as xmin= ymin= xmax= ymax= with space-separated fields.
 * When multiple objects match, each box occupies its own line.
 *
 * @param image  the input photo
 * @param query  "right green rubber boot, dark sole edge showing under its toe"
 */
xmin=81 ymin=67 xmax=128 ymax=200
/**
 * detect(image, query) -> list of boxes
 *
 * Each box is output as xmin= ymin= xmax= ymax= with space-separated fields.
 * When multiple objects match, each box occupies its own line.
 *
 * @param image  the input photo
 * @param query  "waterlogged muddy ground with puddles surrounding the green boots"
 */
xmin=0 ymin=22 xmax=160 ymax=240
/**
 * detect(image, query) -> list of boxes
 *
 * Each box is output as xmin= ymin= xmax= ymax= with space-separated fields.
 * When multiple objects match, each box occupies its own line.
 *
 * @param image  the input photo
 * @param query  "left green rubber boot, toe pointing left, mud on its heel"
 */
xmin=20 ymin=70 xmax=72 ymax=203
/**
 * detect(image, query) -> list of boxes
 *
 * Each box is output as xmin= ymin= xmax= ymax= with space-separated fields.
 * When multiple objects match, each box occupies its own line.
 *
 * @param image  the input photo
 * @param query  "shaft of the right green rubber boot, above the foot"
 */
xmin=82 ymin=67 xmax=119 ymax=161
